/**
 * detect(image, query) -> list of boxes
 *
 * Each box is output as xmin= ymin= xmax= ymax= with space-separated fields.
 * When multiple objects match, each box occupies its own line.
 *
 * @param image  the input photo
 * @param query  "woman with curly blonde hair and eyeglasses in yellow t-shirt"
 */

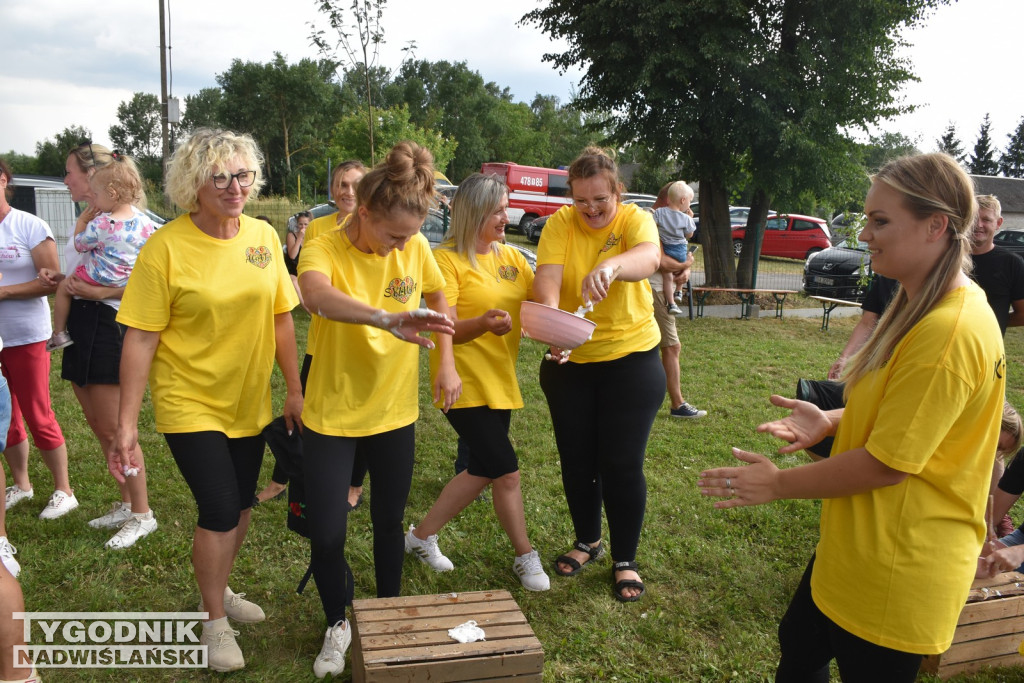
xmin=116 ymin=129 xmax=302 ymax=671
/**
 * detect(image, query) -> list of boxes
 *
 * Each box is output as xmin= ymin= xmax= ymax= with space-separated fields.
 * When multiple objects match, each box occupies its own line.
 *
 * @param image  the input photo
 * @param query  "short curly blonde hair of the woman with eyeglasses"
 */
xmin=167 ymin=128 xmax=265 ymax=211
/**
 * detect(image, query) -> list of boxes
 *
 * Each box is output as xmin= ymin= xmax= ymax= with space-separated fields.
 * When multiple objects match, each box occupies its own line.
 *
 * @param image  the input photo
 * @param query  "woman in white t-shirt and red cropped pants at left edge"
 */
xmin=0 ymin=162 xmax=78 ymax=524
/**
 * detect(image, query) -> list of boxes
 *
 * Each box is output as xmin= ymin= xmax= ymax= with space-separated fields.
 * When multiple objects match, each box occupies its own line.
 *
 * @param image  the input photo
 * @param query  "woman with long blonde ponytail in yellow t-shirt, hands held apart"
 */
xmin=698 ymin=154 xmax=1006 ymax=682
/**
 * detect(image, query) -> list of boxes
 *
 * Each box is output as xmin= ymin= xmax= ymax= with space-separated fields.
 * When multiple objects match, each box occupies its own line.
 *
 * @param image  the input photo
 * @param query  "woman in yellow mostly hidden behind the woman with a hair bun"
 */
xmin=256 ymin=159 xmax=367 ymax=509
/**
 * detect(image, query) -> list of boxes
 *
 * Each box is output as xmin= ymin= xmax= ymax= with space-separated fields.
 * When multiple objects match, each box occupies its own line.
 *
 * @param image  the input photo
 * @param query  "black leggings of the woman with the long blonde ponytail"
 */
xmin=775 ymin=557 xmax=923 ymax=683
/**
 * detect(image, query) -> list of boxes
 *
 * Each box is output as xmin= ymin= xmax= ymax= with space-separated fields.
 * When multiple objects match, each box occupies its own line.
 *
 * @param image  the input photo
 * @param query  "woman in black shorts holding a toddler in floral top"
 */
xmin=54 ymin=142 xmax=157 ymax=549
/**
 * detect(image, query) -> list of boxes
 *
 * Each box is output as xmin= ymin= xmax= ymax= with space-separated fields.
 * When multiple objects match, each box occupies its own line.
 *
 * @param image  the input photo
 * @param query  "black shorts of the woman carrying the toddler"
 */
xmin=60 ymin=299 xmax=127 ymax=386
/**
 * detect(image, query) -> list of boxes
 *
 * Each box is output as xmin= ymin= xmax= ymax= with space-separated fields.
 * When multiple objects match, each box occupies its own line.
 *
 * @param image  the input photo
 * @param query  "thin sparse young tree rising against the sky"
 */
xmin=309 ymin=0 xmax=387 ymax=164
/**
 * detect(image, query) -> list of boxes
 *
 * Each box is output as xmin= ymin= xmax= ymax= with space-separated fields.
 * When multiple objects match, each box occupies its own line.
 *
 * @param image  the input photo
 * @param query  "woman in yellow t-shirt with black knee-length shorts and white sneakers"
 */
xmin=406 ymin=173 xmax=550 ymax=591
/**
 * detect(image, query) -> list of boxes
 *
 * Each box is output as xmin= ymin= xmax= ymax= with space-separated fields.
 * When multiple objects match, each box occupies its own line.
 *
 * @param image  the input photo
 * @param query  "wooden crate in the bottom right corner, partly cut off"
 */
xmin=921 ymin=571 xmax=1024 ymax=678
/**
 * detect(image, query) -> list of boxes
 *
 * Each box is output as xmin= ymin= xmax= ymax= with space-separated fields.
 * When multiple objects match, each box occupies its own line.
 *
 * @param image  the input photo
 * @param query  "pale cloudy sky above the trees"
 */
xmin=0 ymin=0 xmax=1024 ymax=154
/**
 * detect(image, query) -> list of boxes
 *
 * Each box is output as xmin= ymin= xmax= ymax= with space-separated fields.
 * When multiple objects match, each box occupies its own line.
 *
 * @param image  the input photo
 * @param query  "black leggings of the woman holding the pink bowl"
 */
xmin=541 ymin=347 xmax=666 ymax=562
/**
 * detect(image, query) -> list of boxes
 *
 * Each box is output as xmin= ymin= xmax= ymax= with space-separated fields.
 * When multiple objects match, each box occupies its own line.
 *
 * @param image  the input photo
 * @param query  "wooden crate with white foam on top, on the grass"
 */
xmin=352 ymin=591 xmax=544 ymax=683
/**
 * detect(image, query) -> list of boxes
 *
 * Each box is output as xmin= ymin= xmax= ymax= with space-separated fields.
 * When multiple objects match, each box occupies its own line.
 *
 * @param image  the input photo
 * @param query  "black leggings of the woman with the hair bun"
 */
xmin=302 ymin=424 xmax=416 ymax=626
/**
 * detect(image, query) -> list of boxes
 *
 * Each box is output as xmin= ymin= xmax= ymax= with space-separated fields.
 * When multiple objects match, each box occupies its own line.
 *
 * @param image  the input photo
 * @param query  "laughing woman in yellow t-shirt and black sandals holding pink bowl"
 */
xmin=534 ymin=147 xmax=666 ymax=602
